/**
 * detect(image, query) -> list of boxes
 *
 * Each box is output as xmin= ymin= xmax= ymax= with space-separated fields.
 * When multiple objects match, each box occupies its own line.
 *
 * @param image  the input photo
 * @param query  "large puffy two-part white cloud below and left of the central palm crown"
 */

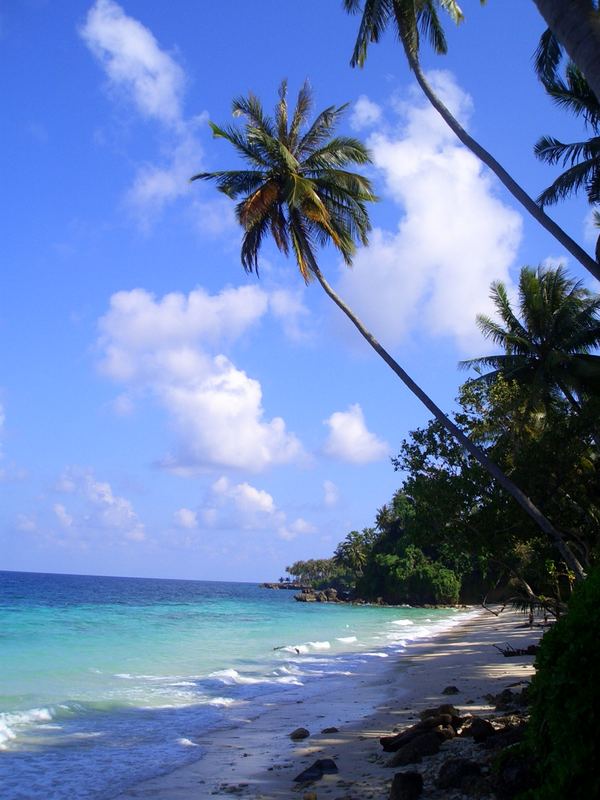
xmin=99 ymin=287 xmax=303 ymax=472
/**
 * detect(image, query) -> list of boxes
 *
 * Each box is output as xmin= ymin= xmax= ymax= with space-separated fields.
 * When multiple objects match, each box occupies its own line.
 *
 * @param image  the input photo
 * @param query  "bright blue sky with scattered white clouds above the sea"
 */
xmin=0 ymin=0 xmax=593 ymax=580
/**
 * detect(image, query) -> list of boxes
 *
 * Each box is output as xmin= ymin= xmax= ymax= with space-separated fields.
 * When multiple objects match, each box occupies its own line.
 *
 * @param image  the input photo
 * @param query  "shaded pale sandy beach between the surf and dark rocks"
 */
xmin=118 ymin=609 xmax=540 ymax=800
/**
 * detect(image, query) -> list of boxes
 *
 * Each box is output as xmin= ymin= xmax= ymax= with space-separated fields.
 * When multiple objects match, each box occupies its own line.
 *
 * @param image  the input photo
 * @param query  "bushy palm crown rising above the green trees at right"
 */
xmin=462 ymin=267 xmax=600 ymax=411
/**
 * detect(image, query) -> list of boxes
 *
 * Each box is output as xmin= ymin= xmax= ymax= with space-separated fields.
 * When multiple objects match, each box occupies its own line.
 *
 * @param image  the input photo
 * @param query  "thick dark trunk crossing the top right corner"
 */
xmin=534 ymin=0 xmax=600 ymax=101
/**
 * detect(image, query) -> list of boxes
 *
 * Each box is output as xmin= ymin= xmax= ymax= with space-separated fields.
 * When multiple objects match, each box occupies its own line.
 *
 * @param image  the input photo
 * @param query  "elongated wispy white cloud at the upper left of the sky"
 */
xmin=80 ymin=0 xmax=184 ymax=125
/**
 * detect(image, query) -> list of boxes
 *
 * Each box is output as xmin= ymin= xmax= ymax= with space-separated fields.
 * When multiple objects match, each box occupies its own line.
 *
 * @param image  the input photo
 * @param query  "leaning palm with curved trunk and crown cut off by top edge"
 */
xmin=344 ymin=0 xmax=600 ymax=280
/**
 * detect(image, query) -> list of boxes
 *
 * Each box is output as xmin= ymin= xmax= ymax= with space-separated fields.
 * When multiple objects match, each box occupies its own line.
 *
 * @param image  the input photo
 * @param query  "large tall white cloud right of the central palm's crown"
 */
xmin=339 ymin=72 xmax=521 ymax=350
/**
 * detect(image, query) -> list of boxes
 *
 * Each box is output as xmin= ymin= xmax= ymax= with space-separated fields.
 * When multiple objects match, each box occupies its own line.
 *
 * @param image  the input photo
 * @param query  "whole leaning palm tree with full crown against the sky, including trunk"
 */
xmin=191 ymin=81 xmax=585 ymax=577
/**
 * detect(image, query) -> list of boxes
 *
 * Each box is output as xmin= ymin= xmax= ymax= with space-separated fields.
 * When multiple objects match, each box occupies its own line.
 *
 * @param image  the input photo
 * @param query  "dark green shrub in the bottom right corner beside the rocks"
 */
xmin=527 ymin=569 xmax=600 ymax=800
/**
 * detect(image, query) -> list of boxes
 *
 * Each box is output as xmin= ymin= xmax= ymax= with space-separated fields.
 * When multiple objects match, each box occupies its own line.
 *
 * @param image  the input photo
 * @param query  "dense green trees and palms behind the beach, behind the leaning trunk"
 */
xmin=288 ymin=269 xmax=600 ymax=616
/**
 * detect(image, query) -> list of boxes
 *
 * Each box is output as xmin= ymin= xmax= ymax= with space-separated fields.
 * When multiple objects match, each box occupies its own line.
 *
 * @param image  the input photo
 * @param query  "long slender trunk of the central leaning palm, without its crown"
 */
xmin=313 ymin=267 xmax=585 ymax=579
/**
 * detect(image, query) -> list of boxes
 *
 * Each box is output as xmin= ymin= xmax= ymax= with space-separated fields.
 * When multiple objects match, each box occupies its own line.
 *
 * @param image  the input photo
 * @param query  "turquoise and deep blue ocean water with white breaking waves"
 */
xmin=0 ymin=572 xmax=474 ymax=800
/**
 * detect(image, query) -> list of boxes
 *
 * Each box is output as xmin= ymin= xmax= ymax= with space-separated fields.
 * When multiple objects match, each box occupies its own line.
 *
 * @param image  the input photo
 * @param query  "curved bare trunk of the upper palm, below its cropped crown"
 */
xmin=404 ymin=46 xmax=600 ymax=280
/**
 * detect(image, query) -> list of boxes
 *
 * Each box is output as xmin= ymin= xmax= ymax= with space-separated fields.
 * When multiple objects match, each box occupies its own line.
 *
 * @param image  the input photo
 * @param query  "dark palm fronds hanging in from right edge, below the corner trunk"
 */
xmin=534 ymin=62 xmax=600 ymax=212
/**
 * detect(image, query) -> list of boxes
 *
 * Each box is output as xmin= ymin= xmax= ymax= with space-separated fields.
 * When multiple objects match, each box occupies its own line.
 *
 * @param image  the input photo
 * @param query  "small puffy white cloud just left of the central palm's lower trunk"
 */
xmin=324 ymin=403 xmax=390 ymax=464
